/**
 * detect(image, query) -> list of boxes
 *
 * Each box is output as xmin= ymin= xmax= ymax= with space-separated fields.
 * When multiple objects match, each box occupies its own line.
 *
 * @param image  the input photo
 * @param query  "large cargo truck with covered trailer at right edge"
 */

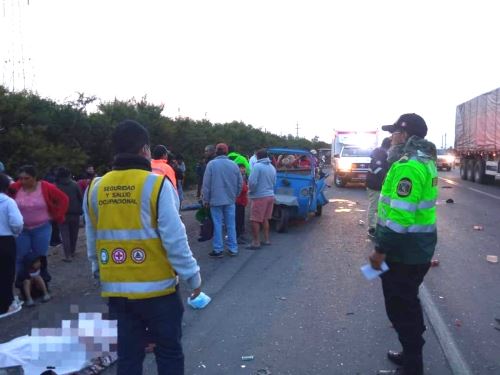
xmin=455 ymin=88 xmax=500 ymax=184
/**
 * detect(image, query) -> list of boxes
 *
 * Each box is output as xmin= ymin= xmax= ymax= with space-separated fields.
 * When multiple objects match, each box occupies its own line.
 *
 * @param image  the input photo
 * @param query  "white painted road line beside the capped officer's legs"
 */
xmin=419 ymin=284 xmax=472 ymax=375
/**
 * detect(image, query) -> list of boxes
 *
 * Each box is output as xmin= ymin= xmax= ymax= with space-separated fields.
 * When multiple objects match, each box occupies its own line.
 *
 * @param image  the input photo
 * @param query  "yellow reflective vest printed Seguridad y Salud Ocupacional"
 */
xmin=87 ymin=169 xmax=177 ymax=299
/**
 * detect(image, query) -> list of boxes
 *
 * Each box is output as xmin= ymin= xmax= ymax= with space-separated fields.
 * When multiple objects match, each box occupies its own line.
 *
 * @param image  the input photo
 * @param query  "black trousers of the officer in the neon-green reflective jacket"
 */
xmin=381 ymin=262 xmax=430 ymax=375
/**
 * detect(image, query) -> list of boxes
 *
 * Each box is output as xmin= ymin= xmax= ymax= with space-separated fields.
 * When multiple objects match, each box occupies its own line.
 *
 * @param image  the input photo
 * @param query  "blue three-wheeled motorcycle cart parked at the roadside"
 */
xmin=268 ymin=148 xmax=328 ymax=232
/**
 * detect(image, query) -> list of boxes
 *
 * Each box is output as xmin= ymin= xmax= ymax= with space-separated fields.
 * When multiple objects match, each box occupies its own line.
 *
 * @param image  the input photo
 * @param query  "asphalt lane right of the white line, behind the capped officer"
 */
xmin=426 ymin=171 xmax=500 ymax=374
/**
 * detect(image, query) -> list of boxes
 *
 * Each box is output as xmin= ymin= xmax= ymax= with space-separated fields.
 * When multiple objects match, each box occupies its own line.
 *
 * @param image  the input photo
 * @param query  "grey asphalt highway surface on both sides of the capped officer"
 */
xmin=0 ymin=171 xmax=500 ymax=375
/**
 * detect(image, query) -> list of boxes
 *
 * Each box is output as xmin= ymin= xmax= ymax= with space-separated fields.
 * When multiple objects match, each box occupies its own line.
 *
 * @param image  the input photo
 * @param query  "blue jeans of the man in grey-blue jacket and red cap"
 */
xmin=210 ymin=204 xmax=238 ymax=253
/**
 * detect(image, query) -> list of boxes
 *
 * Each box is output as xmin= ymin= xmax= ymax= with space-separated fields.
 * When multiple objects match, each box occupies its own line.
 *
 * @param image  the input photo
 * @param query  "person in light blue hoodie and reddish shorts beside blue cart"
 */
xmin=247 ymin=149 xmax=276 ymax=250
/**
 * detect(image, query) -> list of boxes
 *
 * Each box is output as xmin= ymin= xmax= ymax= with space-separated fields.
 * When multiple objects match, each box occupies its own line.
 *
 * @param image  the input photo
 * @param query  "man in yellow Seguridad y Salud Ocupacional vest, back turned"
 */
xmin=84 ymin=120 xmax=201 ymax=375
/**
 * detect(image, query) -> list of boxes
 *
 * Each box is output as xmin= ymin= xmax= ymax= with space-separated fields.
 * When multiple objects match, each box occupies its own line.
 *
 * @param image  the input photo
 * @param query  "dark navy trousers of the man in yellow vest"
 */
xmin=108 ymin=291 xmax=184 ymax=375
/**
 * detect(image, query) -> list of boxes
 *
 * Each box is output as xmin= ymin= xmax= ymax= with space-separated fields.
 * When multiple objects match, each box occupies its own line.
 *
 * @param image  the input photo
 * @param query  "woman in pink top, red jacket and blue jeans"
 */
xmin=11 ymin=165 xmax=68 ymax=290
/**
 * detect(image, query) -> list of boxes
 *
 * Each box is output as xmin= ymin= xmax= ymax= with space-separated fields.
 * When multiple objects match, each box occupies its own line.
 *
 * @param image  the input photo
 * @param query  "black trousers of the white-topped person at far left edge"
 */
xmin=0 ymin=236 xmax=16 ymax=314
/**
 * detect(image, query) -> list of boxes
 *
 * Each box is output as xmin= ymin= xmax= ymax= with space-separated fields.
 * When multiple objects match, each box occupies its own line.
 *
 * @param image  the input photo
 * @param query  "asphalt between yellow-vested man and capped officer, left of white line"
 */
xmin=118 ymin=181 xmax=451 ymax=375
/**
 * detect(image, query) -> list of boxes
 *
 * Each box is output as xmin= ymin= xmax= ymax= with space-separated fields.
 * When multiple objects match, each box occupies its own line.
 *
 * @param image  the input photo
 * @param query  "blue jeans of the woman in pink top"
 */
xmin=16 ymin=222 xmax=52 ymax=270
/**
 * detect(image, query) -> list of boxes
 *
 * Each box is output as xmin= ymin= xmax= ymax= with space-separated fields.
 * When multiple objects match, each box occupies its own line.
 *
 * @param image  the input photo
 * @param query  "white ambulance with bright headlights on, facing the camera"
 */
xmin=332 ymin=130 xmax=378 ymax=187
